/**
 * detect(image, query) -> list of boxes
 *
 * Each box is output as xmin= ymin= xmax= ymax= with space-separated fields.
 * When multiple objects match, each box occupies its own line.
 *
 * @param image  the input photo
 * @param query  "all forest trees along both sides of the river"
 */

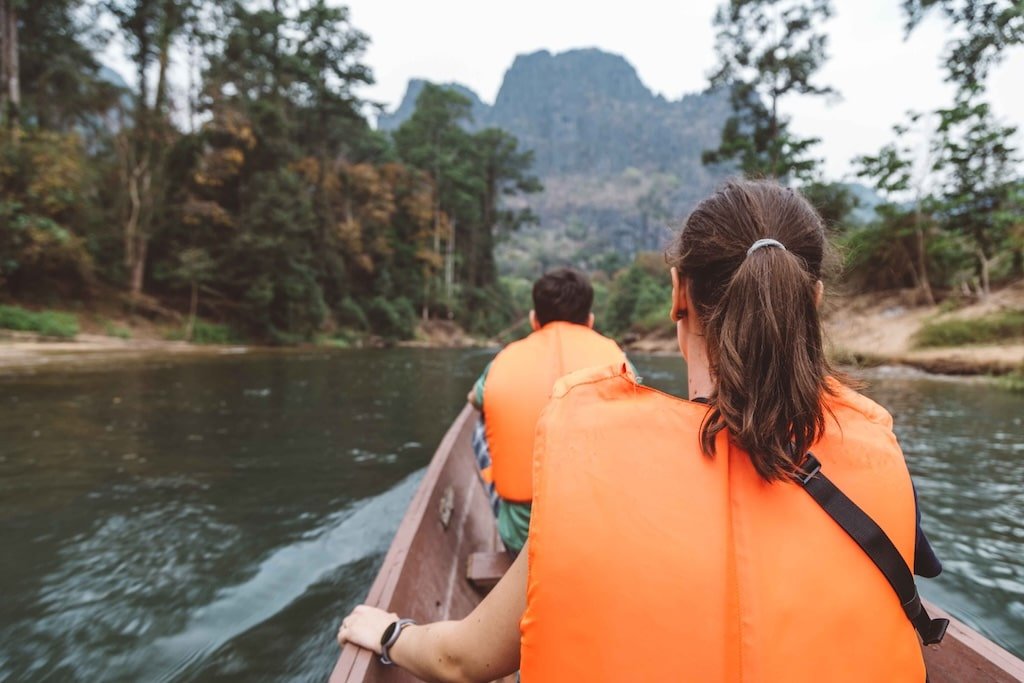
xmin=0 ymin=0 xmax=1024 ymax=344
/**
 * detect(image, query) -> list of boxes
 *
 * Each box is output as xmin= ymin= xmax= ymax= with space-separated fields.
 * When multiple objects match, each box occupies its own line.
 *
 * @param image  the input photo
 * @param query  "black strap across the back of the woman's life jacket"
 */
xmin=799 ymin=453 xmax=949 ymax=645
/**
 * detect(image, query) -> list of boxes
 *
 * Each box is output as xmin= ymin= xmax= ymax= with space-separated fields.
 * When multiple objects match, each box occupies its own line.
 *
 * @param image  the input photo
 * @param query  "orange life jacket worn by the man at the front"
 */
xmin=483 ymin=322 xmax=625 ymax=503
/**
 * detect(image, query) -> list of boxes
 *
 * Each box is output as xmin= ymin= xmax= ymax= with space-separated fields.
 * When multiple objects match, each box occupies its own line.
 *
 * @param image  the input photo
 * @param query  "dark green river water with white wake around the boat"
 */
xmin=0 ymin=349 xmax=1024 ymax=681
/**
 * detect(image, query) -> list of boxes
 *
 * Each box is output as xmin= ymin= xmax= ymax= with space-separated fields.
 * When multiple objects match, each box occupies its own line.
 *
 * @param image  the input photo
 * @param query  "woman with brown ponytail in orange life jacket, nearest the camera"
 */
xmin=338 ymin=181 xmax=941 ymax=683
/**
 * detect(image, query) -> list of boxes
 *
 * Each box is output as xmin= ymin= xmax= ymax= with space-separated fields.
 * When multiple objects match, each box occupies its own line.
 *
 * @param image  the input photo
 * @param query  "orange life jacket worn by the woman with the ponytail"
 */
xmin=520 ymin=369 xmax=925 ymax=683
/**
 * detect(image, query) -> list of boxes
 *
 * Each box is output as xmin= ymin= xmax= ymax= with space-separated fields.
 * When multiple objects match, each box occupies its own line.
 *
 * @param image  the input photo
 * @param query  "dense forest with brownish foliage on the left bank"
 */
xmin=0 ymin=0 xmax=539 ymax=343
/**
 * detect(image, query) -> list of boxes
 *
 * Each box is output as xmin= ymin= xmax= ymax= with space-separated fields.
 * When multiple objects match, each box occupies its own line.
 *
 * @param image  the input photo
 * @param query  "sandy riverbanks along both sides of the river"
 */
xmin=0 ymin=282 xmax=1024 ymax=376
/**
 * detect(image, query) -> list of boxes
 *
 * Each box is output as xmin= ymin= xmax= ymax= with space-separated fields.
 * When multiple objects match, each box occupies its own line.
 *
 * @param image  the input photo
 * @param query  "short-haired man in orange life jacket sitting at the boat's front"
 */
xmin=467 ymin=268 xmax=626 ymax=553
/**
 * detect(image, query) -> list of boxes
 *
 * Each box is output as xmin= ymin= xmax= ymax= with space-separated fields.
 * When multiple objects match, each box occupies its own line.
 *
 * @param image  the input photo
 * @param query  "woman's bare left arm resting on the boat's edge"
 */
xmin=338 ymin=548 xmax=527 ymax=681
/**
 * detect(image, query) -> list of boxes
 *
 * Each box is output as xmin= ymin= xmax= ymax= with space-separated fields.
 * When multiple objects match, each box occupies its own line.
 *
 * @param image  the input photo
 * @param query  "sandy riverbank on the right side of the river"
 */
xmin=626 ymin=283 xmax=1024 ymax=375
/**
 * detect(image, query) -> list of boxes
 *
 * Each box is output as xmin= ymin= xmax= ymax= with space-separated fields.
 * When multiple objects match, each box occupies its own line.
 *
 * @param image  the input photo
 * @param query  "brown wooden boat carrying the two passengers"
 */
xmin=330 ymin=407 xmax=1024 ymax=683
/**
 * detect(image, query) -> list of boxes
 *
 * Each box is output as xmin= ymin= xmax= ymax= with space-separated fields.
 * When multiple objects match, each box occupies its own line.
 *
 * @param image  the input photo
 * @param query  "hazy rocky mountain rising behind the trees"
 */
xmin=378 ymin=49 xmax=729 ymax=275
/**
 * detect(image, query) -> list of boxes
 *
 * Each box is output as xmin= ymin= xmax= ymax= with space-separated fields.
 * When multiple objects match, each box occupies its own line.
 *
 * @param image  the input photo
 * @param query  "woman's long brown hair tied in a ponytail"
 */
xmin=667 ymin=181 xmax=835 ymax=481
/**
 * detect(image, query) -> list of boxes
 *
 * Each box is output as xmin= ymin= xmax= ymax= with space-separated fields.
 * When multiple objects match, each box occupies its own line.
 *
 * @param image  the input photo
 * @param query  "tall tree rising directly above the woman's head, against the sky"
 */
xmin=702 ymin=0 xmax=835 ymax=182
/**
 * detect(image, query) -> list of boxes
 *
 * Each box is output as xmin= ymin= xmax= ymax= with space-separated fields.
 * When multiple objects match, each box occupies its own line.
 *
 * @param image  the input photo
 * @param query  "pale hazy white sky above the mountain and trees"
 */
xmin=337 ymin=0 xmax=1024 ymax=178
